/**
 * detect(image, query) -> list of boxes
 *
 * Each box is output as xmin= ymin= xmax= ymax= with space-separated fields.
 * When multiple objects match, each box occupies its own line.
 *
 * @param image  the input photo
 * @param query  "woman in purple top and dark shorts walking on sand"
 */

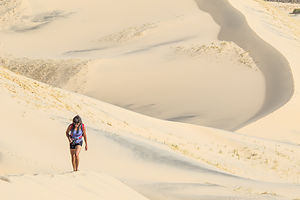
xmin=66 ymin=115 xmax=88 ymax=171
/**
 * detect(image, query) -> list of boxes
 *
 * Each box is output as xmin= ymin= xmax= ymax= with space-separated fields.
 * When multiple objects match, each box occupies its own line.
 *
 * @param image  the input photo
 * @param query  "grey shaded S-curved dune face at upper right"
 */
xmin=196 ymin=0 xmax=294 ymax=130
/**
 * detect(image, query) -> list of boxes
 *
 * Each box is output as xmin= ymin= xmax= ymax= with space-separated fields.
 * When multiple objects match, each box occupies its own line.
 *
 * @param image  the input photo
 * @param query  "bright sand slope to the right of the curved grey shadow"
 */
xmin=232 ymin=1 xmax=300 ymax=145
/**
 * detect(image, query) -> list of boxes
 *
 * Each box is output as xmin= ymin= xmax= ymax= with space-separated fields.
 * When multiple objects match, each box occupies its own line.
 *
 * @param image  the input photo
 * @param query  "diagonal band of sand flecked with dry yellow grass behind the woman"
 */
xmin=1 ymin=64 xmax=300 ymax=183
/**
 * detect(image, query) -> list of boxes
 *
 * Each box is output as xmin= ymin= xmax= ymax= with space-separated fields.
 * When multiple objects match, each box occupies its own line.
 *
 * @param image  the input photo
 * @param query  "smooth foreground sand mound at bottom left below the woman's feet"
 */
xmin=0 ymin=172 xmax=147 ymax=200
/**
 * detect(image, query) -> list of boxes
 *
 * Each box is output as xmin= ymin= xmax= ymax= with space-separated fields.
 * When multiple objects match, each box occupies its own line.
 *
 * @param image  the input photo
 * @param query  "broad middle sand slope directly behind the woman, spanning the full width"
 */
xmin=0 ymin=65 xmax=299 ymax=199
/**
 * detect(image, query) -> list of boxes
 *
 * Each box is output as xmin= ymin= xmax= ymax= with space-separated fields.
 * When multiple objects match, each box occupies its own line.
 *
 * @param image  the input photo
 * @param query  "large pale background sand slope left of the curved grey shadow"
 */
xmin=0 ymin=0 xmax=265 ymax=130
